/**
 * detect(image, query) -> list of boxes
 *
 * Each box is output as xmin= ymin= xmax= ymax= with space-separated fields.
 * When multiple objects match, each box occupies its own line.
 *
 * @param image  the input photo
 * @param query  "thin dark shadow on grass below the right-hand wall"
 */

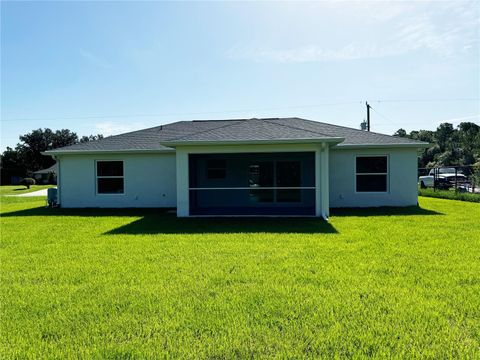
xmin=330 ymin=206 xmax=445 ymax=217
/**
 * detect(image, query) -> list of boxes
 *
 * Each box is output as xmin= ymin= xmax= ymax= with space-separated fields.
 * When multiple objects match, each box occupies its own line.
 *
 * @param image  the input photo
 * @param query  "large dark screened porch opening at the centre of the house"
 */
xmin=189 ymin=152 xmax=315 ymax=215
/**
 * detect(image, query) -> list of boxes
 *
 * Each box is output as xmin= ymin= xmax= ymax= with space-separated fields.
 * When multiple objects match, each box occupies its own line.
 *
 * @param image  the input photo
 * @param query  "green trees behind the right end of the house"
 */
xmin=393 ymin=122 xmax=480 ymax=168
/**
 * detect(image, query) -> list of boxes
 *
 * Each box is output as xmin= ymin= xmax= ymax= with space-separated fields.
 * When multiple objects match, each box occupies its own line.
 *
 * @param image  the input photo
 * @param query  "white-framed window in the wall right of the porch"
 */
xmin=356 ymin=156 xmax=388 ymax=192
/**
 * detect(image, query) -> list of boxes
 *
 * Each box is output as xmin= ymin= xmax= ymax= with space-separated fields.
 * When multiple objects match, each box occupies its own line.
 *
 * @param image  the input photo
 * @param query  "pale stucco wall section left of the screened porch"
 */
xmin=59 ymin=153 xmax=177 ymax=208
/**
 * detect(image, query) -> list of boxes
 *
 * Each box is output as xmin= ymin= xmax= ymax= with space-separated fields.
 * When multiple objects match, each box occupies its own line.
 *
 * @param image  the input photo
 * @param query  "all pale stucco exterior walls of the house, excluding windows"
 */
xmin=55 ymin=145 xmax=417 ymax=210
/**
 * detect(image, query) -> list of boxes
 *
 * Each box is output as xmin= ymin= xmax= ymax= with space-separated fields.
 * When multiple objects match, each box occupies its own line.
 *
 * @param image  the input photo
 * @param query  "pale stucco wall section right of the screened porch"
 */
xmin=329 ymin=148 xmax=418 ymax=208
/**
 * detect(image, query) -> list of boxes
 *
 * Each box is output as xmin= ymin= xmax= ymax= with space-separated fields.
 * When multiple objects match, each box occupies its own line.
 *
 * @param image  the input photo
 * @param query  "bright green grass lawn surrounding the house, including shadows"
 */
xmin=0 ymin=197 xmax=480 ymax=359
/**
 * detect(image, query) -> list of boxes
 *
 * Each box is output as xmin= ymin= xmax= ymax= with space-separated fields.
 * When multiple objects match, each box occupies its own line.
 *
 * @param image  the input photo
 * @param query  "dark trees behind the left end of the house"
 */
xmin=0 ymin=128 xmax=103 ymax=184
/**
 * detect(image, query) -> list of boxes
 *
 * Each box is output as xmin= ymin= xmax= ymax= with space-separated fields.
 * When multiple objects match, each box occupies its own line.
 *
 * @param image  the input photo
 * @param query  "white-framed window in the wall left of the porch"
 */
xmin=97 ymin=160 xmax=124 ymax=194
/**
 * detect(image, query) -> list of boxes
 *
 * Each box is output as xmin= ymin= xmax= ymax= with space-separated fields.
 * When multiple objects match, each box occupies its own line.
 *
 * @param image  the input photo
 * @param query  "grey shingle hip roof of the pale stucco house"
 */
xmin=47 ymin=118 xmax=425 ymax=153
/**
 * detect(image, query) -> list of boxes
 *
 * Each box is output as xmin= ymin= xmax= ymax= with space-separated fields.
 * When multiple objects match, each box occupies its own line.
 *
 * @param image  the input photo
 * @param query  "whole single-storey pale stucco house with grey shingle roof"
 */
xmin=45 ymin=118 xmax=428 ymax=218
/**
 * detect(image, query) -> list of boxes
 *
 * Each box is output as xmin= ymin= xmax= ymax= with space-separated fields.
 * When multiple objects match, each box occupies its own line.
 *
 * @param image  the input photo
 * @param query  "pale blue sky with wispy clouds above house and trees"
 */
xmin=1 ymin=1 xmax=480 ymax=150
